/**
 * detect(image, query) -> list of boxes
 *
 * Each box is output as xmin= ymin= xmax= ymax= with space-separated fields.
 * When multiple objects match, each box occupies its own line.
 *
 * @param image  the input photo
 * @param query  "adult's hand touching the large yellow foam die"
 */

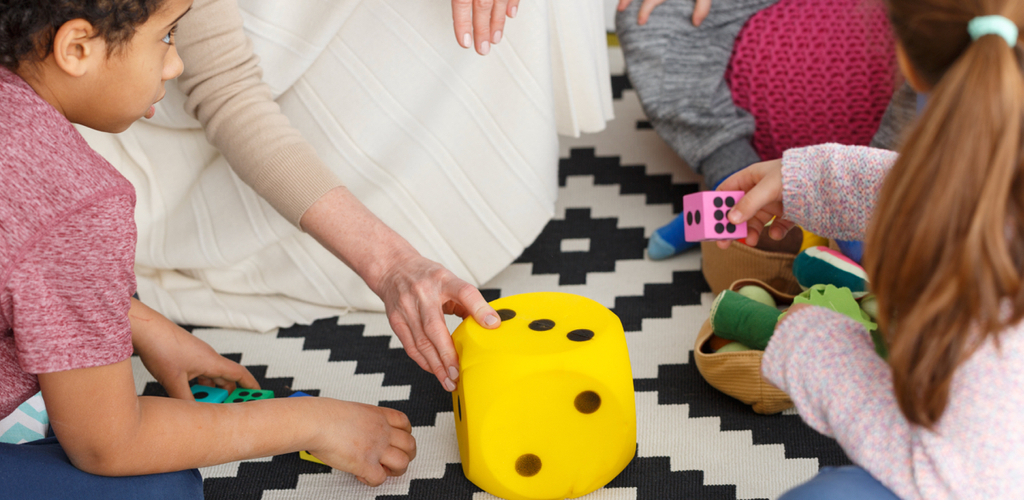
xmin=375 ymin=254 xmax=501 ymax=391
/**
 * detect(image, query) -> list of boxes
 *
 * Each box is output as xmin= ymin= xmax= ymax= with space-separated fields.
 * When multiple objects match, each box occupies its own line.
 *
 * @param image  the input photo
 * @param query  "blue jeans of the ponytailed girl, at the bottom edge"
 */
xmin=778 ymin=466 xmax=899 ymax=500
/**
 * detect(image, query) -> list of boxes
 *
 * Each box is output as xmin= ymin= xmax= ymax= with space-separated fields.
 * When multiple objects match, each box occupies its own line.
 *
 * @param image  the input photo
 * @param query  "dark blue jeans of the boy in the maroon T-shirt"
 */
xmin=0 ymin=438 xmax=203 ymax=500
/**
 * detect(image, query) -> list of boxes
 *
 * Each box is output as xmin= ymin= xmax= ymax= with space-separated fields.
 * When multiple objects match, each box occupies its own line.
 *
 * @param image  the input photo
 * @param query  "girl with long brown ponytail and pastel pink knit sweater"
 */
xmin=719 ymin=0 xmax=1024 ymax=500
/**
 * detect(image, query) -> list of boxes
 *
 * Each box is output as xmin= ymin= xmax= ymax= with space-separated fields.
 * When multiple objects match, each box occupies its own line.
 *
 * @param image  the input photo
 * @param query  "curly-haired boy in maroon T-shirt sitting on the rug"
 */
xmin=0 ymin=0 xmax=416 ymax=498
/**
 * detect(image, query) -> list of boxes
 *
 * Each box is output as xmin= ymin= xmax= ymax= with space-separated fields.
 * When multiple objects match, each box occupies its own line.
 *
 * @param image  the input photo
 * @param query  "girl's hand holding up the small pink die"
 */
xmin=718 ymin=160 xmax=796 ymax=249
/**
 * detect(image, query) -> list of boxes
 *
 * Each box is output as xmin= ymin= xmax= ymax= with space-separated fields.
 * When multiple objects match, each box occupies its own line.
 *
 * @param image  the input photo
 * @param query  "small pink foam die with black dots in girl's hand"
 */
xmin=683 ymin=191 xmax=746 ymax=242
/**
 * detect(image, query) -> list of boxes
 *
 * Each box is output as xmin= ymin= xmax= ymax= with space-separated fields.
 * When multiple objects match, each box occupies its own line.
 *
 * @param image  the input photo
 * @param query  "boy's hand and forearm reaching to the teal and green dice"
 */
xmin=128 ymin=299 xmax=259 ymax=400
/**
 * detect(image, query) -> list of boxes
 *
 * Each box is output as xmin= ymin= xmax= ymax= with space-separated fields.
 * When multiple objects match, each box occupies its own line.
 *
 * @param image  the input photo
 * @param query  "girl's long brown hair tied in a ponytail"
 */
xmin=864 ymin=0 xmax=1024 ymax=427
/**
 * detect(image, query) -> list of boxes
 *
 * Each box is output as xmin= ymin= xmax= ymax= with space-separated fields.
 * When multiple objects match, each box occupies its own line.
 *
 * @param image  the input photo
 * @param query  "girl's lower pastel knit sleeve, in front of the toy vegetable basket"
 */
xmin=761 ymin=307 xmax=920 ymax=499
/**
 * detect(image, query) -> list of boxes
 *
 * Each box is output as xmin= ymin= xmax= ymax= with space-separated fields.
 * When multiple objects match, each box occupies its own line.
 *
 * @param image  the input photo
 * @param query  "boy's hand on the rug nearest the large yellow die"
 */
xmin=307 ymin=399 xmax=416 ymax=486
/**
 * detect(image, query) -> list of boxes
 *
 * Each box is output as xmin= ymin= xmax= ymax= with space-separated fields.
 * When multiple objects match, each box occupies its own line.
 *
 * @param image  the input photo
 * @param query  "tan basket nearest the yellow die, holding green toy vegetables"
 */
xmin=693 ymin=276 xmax=799 ymax=415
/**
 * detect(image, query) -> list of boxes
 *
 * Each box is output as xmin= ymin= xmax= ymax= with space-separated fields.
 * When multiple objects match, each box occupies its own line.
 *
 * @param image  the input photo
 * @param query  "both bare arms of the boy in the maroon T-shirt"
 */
xmin=39 ymin=309 xmax=416 ymax=486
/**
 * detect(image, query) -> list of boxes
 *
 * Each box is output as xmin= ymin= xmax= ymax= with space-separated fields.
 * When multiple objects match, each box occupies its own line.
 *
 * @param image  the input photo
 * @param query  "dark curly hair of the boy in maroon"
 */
xmin=0 ymin=0 xmax=164 ymax=71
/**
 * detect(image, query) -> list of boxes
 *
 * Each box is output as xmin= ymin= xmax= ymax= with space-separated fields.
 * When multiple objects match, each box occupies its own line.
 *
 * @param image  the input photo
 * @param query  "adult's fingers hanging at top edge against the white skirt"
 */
xmin=452 ymin=0 xmax=519 ymax=55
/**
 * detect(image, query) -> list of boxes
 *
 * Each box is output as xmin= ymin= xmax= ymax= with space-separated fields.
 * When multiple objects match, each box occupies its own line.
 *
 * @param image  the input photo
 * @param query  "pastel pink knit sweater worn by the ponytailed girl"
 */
xmin=762 ymin=144 xmax=1024 ymax=500
